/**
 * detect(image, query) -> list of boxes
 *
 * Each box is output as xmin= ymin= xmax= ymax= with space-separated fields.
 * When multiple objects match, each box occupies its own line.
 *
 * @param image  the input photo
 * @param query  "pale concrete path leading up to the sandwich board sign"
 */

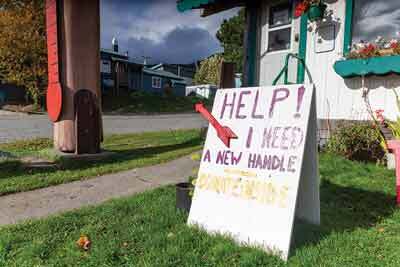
xmin=0 ymin=156 xmax=199 ymax=226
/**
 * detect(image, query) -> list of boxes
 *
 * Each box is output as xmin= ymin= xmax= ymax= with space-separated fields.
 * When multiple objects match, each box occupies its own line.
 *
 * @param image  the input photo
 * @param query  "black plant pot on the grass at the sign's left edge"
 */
xmin=175 ymin=153 xmax=201 ymax=212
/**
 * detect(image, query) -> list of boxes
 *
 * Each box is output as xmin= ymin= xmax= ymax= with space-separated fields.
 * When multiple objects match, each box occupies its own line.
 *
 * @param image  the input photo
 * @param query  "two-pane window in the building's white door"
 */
xmin=268 ymin=3 xmax=292 ymax=52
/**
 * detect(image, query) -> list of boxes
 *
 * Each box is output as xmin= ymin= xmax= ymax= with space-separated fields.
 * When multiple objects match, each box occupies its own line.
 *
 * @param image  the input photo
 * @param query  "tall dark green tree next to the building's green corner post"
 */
xmin=217 ymin=9 xmax=246 ymax=72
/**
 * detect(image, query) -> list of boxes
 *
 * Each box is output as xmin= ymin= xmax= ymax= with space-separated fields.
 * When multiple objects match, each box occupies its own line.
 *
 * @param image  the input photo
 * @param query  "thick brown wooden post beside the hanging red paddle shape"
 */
xmin=54 ymin=0 xmax=102 ymax=152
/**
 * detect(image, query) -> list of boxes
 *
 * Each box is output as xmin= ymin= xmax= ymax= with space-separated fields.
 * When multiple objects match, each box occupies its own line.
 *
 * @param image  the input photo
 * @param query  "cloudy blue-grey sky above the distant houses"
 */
xmin=101 ymin=0 xmax=238 ymax=64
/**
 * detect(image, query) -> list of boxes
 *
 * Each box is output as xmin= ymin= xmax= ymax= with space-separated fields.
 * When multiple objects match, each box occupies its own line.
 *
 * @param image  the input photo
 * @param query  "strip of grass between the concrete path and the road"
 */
xmin=0 ymin=130 xmax=202 ymax=196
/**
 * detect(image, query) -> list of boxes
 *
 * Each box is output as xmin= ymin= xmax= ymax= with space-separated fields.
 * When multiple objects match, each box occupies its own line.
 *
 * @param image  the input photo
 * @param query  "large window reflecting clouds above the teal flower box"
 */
xmin=352 ymin=0 xmax=400 ymax=44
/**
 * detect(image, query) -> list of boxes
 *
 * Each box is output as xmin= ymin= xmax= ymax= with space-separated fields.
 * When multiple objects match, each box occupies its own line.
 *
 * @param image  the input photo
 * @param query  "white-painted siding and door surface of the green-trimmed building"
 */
xmin=258 ymin=0 xmax=400 ymax=120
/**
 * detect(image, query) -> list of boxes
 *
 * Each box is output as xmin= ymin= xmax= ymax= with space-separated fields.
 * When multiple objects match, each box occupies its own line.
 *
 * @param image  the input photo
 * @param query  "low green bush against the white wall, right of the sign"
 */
xmin=326 ymin=123 xmax=385 ymax=163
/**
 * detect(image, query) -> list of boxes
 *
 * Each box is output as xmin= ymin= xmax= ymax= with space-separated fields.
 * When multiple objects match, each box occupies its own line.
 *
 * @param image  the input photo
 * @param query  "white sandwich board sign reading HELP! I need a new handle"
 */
xmin=188 ymin=85 xmax=320 ymax=260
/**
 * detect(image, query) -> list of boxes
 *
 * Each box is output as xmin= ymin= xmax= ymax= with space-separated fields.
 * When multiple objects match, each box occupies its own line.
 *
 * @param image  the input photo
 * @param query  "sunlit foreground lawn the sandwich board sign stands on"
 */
xmin=0 ymin=155 xmax=400 ymax=267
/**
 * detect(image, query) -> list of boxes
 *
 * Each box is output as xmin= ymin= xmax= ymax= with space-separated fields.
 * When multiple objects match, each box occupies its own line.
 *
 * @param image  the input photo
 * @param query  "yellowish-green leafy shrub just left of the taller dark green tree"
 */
xmin=193 ymin=54 xmax=223 ymax=85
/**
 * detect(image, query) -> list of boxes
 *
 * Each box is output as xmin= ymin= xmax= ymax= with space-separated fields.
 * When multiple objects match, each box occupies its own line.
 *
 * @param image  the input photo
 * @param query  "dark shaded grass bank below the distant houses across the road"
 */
xmin=103 ymin=91 xmax=209 ymax=114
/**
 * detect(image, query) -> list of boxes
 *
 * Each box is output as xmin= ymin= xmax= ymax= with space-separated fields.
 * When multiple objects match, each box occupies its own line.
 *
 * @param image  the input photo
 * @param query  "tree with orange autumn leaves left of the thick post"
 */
xmin=0 ymin=0 xmax=47 ymax=104
